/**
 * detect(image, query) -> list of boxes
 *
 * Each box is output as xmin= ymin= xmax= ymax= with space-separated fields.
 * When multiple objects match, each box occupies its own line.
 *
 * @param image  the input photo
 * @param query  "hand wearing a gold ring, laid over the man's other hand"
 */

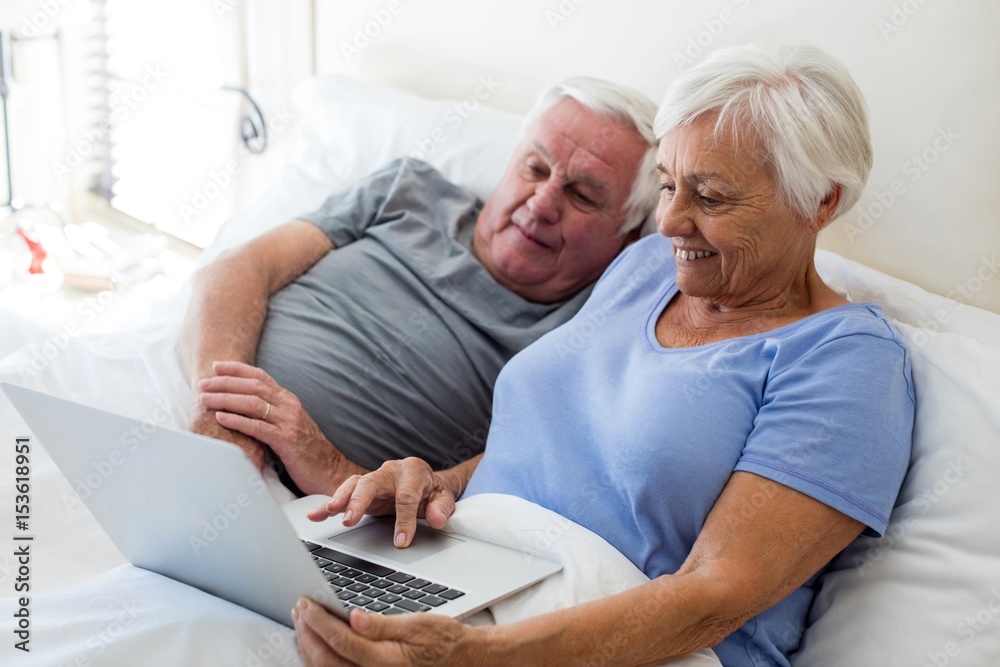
xmin=198 ymin=361 xmax=366 ymax=493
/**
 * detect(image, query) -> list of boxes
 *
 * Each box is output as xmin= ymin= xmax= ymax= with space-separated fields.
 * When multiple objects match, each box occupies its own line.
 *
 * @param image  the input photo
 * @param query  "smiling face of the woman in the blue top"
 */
xmin=656 ymin=114 xmax=819 ymax=308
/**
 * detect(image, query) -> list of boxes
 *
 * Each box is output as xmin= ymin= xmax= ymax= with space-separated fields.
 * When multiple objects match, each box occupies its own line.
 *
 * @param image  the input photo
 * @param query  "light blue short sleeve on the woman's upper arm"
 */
xmin=735 ymin=332 xmax=914 ymax=536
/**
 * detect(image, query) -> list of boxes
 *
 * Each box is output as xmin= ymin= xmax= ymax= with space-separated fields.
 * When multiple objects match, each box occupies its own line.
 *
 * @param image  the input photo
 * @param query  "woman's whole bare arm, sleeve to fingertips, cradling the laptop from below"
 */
xmin=295 ymin=472 xmax=862 ymax=665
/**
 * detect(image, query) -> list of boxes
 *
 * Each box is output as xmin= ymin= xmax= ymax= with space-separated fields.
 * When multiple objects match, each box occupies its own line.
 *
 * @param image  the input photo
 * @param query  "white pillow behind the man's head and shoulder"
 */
xmin=200 ymin=74 xmax=521 ymax=264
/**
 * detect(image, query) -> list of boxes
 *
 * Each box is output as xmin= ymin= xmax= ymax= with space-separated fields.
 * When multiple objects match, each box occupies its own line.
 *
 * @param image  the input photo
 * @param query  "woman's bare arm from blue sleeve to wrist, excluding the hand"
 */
xmin=472 ymin=472 xmax=863 ymax=664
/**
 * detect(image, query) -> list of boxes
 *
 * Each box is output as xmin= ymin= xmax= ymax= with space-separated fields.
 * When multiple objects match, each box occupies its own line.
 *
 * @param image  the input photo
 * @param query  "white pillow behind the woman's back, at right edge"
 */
xmin=792 ymin=253 xmax=1000 ymax=667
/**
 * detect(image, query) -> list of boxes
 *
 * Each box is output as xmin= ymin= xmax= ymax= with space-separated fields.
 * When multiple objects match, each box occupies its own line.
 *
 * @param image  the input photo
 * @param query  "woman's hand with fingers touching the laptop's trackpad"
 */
xmin=308 ymin=457 xmax=465 ymax=547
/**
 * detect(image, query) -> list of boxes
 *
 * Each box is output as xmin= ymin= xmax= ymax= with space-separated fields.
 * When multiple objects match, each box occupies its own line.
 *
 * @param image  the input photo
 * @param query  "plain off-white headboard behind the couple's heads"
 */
xmin=314 ymin=0 xmax=1000 ymax=312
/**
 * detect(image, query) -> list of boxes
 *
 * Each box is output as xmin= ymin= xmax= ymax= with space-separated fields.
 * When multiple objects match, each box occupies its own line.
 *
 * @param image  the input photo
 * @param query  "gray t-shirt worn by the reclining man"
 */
xmin=256 ymin=159 xmax=590 ymax=469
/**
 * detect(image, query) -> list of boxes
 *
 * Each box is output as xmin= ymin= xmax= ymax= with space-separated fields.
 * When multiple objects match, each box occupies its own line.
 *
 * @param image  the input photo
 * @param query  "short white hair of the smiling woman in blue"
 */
xmin=653 ymin=44 xmax=872 ymax=220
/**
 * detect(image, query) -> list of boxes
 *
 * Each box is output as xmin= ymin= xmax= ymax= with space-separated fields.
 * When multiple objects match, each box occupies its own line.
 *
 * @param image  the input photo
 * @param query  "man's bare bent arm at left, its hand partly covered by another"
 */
xmin=178 ymin=220 xmax=335 ymax=468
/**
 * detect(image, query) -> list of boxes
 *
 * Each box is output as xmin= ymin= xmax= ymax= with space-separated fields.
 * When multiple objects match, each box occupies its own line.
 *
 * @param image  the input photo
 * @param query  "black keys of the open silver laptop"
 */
xmin=302 ymin=540 xmax=465 ymax=616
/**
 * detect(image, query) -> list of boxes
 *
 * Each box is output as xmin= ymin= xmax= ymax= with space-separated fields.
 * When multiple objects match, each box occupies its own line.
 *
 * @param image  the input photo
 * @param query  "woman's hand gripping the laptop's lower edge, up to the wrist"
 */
xmin=292 ymin=598 xmax=482 ymax=667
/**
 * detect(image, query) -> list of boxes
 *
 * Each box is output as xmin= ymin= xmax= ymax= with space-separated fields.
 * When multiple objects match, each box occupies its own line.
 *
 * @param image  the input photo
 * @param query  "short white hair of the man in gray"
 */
xmin=518 ymin=76 xmax=659 ymax=235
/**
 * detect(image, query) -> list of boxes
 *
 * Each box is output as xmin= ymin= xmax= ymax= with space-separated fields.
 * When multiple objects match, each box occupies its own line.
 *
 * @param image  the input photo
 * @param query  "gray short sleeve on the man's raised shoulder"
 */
xmin=300 ymin=158 xmax=409 ymax=248
